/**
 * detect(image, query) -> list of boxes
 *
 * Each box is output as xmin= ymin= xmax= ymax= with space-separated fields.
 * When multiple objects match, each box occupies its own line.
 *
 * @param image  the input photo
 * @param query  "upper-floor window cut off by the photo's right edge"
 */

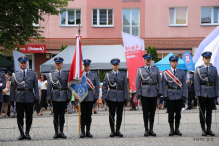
xmin=201 ymin=7 xmax=219 ymax=25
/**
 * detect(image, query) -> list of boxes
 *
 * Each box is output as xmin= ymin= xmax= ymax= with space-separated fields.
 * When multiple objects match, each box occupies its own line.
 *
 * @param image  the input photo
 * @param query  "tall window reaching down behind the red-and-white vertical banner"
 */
xmin=122 ymin=9 xmax=140 ymax=36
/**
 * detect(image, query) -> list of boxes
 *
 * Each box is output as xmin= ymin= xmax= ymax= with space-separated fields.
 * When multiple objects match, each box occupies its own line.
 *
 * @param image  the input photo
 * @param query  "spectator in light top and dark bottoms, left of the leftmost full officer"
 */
xmin=1 ymin=75 xmax=11 ymax=118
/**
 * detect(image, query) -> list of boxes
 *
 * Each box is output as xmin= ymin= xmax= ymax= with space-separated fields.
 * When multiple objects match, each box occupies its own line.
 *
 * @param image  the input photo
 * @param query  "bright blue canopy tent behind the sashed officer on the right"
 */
xmin=155 ymin=52 xmax=187 ymax=71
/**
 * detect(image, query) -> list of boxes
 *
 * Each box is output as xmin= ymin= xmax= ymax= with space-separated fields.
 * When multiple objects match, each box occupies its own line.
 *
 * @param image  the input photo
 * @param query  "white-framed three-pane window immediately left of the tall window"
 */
xmin=92 ymin=9 xmax=113 ymax=27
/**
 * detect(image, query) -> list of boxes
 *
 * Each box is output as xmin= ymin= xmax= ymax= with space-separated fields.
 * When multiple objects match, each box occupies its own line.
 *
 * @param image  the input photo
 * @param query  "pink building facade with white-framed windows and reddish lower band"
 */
xmin=2 ymin=0 xmax=219 ymax=72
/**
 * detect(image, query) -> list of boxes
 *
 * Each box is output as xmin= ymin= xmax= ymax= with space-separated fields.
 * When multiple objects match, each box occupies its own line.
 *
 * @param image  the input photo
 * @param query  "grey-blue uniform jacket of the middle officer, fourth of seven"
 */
xmin=102 ymin=71 xmax=128 ymax=102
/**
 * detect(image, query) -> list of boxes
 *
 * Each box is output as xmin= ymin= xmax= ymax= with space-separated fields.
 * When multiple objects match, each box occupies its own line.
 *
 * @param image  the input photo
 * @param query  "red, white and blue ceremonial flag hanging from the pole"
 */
xmin=68 ymin=35 xmax=88 ymax=102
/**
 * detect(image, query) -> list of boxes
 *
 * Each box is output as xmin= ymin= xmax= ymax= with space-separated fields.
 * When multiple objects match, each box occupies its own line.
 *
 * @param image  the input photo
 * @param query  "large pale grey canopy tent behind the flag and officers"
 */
xmin=40 ymin=45 xmax=127 ymax=72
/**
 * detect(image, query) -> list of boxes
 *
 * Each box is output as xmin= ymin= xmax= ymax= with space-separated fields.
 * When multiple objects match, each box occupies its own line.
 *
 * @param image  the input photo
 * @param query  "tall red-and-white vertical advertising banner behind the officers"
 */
xmin=122 ymin=32 xmax=145 ymax=91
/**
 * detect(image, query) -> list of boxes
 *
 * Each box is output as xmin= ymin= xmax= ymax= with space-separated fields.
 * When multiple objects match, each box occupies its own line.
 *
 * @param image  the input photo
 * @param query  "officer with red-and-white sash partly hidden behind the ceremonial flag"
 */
xmin=80 ymin=59 xmax=99 ymax=138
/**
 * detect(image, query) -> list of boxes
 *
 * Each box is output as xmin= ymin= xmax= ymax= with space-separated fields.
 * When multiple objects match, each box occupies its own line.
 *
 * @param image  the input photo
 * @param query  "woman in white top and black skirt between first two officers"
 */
xmin=38 ymin=75 xmax=47 ymax=116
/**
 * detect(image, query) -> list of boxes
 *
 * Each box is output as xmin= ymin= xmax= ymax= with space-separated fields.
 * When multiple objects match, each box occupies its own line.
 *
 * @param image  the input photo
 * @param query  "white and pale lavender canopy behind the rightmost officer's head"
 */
xmin=193 ymin=26 xmax=219 ymax=73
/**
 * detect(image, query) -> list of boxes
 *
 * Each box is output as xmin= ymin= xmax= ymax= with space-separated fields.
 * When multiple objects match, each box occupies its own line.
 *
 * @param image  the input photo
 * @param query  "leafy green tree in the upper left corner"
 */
xmin=0 ymin=0 xmax=70 ymax=50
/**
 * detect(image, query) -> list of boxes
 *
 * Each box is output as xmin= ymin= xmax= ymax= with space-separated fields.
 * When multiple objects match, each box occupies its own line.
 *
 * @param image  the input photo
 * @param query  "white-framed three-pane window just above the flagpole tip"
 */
xmin=60 ymin=9 xmax=81 ymax=26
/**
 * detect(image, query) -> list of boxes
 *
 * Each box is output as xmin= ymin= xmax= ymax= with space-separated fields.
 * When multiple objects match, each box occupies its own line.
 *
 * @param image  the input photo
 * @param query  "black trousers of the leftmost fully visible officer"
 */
xmin=16 ymin=102 xmax=33 ymax=133
